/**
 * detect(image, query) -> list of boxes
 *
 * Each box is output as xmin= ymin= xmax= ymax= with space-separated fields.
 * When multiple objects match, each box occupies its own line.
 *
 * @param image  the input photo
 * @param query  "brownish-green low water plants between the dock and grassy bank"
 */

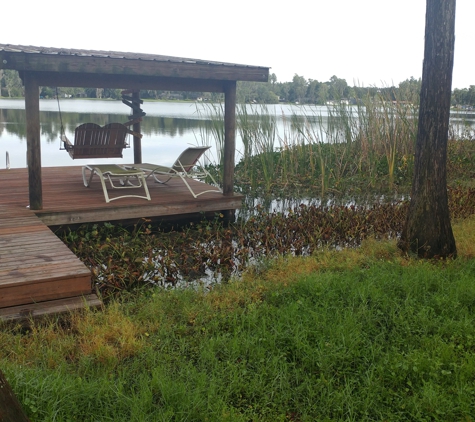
xmin=55 ymin=188 xmax=475 ymax=298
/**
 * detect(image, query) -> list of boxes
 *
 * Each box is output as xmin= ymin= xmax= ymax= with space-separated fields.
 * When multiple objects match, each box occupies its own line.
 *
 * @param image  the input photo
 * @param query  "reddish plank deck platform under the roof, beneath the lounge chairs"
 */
xmin=0 ymin=166 xmax=243 ymax=226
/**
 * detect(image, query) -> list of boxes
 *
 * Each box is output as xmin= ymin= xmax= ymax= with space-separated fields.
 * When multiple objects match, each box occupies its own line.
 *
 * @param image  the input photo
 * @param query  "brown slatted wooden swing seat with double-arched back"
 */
xmin=71 ymin=123 xmax=129 ymax=159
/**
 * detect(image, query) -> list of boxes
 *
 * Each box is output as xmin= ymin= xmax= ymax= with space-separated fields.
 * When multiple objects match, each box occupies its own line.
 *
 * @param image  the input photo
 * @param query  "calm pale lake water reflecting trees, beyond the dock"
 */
xmin=0 ymin=99 xmax=475 ymax=168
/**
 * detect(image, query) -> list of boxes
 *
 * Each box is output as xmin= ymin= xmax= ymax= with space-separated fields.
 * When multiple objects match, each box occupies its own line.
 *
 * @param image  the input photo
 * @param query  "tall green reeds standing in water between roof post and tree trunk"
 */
xmin=233 ymin=96 xmax=417 ymax=196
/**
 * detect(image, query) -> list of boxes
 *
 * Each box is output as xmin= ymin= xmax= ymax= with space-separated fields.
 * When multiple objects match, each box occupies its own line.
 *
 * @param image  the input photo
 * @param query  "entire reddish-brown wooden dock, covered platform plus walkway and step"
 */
xmin=0 ymin=166 xmax=242 ymax=319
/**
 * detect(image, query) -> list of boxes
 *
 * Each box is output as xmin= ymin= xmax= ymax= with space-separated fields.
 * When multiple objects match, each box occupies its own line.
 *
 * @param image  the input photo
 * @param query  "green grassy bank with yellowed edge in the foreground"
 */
xmin=0 ymin=219 xmax=475 ymax=421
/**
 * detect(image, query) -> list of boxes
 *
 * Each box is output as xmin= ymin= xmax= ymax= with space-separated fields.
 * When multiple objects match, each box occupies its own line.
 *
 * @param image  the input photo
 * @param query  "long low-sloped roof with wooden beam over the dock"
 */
xmin=0 ymin=44 xmax=269 ymax=92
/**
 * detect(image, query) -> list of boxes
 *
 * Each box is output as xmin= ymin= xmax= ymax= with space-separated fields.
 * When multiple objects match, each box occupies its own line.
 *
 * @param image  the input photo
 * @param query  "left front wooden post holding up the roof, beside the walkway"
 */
xmin=23 ymin=72 xmax=43 ymax=210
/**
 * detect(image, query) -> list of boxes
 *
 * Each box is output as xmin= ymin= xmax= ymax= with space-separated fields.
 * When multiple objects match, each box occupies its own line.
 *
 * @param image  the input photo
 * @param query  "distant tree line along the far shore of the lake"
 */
xmin=0 ymin=69 xmax=475 ymax=107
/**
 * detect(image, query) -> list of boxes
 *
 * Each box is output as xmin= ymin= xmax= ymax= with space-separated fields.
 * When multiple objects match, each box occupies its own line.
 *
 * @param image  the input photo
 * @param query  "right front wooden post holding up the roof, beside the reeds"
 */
xmin=223 ymin=81 xmax=236 ymax=196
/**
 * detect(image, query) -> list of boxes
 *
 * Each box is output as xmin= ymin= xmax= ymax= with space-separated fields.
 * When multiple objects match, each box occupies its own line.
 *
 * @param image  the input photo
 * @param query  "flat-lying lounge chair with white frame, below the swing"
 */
xmin=82 ymin=164 xmax=151 ymax=202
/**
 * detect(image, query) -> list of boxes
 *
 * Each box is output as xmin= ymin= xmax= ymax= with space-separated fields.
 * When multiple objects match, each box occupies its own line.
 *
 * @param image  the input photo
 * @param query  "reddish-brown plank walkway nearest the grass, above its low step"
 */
xmin=0 ymin=203 xmax=91 ymax=308
